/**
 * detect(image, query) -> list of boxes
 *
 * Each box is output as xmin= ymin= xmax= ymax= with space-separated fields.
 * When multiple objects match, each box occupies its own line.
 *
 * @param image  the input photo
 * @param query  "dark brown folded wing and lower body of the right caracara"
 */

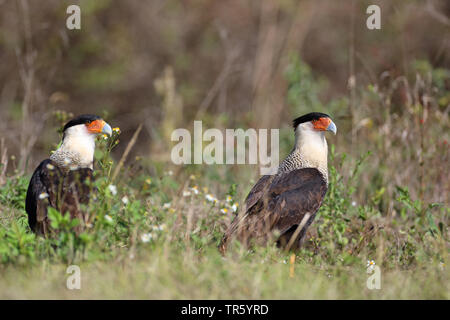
xmin=223 ymin=168 xmax=327 ymax=248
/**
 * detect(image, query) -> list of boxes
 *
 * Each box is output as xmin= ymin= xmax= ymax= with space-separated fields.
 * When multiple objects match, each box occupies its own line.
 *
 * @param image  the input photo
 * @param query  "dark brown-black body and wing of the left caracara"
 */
xmin=25 ymin=159 xmax=92 ymax=235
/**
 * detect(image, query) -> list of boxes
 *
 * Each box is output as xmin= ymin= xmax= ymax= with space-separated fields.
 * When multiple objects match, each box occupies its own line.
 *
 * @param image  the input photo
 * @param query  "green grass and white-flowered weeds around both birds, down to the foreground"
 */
xmin=0 ymin=141 xmax=449 ymax=299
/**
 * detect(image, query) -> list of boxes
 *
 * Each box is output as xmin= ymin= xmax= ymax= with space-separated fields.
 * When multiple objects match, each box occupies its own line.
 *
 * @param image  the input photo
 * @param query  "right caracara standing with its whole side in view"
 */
xmin=219 ymin=112 xmax=337 ymax=253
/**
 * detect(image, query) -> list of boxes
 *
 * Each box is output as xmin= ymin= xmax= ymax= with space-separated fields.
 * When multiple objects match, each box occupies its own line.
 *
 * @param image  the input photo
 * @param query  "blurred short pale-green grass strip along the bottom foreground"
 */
xmin=0 ymin=246 xmax=448 ymax=299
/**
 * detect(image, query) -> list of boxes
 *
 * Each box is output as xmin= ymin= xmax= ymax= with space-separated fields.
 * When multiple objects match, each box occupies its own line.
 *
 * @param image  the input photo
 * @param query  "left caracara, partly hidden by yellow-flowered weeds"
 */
xmin=25 ymin=114 xmax=112 ymax=236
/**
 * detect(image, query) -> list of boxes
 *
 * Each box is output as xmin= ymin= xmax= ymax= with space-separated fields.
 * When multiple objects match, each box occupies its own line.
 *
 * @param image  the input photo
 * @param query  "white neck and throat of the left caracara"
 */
xmin=50 ymin=124 xmax=96 ymax=169
